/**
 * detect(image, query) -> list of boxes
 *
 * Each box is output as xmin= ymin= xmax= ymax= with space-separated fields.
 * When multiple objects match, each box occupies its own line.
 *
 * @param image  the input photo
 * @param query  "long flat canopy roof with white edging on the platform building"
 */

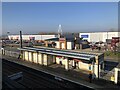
xmin=18 ymin=47 xmax=96 ymax=61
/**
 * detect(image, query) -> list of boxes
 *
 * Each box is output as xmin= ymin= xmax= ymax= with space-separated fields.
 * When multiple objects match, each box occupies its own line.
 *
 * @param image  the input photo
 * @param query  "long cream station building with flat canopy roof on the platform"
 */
xmin=19 ymin=47 xmax=104 ymax=78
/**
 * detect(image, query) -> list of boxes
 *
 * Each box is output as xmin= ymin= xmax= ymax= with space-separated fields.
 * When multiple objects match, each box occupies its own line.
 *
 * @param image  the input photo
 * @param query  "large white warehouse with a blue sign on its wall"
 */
xmin=79 ymin=32 xmax=120 ymax=42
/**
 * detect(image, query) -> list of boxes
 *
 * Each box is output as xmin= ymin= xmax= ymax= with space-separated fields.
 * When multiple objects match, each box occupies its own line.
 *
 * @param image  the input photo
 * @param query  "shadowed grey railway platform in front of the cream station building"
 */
xmin=2 ymin=55 xmax=120 ymax=90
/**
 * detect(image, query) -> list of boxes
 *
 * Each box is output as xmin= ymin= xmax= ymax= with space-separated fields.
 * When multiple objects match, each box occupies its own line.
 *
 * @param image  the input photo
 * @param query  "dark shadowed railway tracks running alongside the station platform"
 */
xmin=2 ymin=60 xmax=94 ymax=89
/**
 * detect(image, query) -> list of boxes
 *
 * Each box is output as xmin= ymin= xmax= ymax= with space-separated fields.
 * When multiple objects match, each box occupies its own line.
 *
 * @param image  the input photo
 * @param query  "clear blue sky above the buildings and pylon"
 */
xmin=2 ymin=2 xmax=118 ymax=34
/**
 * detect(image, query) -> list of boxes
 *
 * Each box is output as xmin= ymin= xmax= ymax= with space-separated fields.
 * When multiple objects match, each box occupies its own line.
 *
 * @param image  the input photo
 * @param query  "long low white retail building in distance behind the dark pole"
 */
xmin=8 ymin=35 xmax=57 ymax=40
